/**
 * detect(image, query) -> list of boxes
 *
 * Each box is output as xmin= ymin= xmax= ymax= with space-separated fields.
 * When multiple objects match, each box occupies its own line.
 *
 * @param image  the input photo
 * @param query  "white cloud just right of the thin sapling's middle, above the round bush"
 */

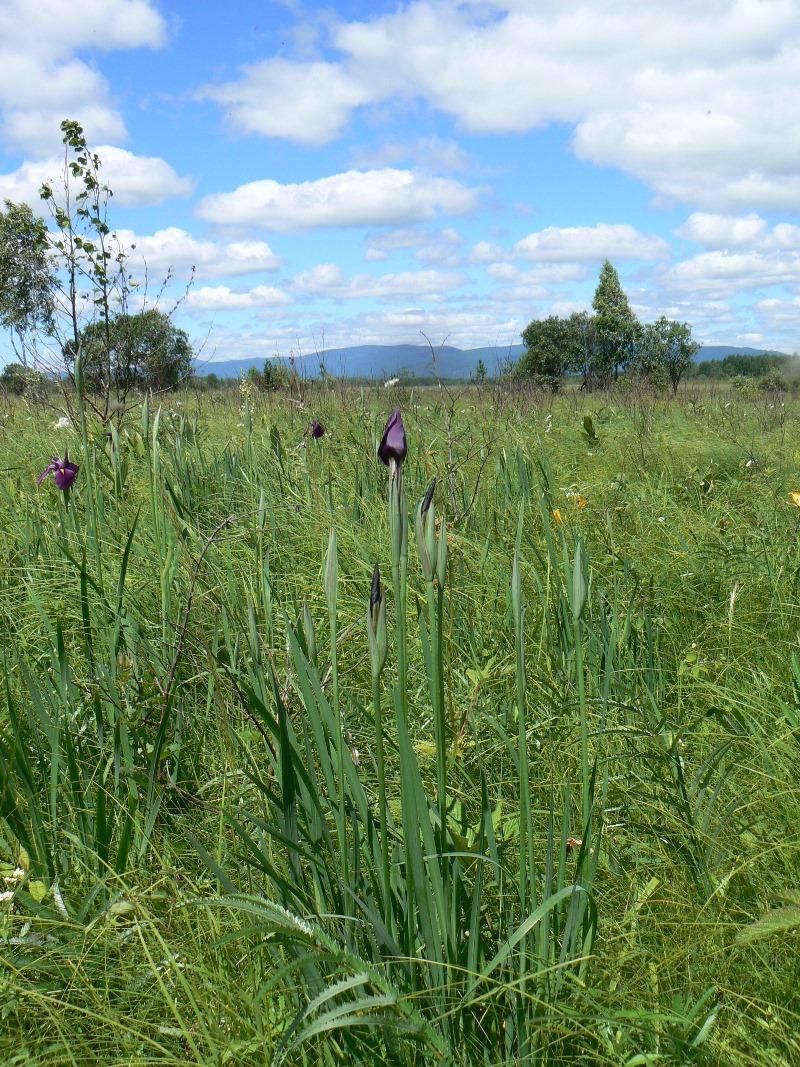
xmin=116 ymin=226 xmax=282 ymax=278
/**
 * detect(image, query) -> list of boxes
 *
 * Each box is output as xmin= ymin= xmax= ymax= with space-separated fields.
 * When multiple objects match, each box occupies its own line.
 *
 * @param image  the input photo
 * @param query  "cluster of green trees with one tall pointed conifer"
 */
xmin=513 ymin=259 xmax=700 ymax=393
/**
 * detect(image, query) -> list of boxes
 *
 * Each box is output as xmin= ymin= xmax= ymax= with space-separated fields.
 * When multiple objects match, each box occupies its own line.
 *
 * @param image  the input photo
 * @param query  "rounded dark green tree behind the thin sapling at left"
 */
xmin=65 ymin=308 xmax=194 ymax=401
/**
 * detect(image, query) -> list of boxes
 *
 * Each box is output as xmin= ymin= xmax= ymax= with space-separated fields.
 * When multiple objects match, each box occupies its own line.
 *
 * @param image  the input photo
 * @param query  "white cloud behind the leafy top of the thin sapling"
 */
xmin=0 ymin=145 xmax=193 ymax=207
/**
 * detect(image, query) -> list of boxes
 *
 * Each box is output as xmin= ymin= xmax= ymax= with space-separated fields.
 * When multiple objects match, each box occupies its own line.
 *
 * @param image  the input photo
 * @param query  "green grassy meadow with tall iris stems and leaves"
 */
xmin=0 ymin=382 xmax=800 ymax=1067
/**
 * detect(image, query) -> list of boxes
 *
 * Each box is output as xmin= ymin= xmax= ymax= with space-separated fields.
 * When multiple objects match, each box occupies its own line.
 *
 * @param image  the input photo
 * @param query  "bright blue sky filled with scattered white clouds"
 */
xmin=0 ymin=0 xmax=800 ymax=362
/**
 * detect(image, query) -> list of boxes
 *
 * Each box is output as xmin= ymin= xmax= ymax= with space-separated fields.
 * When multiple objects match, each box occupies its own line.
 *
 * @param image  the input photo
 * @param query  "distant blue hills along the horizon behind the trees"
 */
xmin=196 ymin=345 xmax=789 ymax=381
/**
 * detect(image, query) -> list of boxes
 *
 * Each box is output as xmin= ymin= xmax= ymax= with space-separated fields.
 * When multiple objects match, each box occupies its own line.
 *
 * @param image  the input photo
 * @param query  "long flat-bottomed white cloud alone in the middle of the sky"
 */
xmin=197 ymin=170 xmax=478 ymax=233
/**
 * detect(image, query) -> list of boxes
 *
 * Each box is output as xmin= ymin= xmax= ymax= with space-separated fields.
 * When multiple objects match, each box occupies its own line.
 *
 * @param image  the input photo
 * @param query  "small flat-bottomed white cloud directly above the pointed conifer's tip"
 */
xmin=514 ymin=222 xmax=669 ymax=262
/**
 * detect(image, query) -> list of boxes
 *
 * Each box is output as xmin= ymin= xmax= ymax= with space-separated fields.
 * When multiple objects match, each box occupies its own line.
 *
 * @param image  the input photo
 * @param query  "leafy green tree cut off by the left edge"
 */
xmin=0 ymin=200 xmax=58 ymax=368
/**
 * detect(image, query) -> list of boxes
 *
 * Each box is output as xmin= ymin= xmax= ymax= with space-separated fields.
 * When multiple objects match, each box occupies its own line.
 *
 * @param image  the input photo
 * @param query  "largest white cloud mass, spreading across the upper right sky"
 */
xmin=203 ymin=0 xmax=800 ymax=209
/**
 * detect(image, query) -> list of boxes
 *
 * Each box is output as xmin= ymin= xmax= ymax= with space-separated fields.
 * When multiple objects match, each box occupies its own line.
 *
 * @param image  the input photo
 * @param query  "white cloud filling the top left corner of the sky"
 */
xmin=0 ymin=0 xmax=166 ymax=156
